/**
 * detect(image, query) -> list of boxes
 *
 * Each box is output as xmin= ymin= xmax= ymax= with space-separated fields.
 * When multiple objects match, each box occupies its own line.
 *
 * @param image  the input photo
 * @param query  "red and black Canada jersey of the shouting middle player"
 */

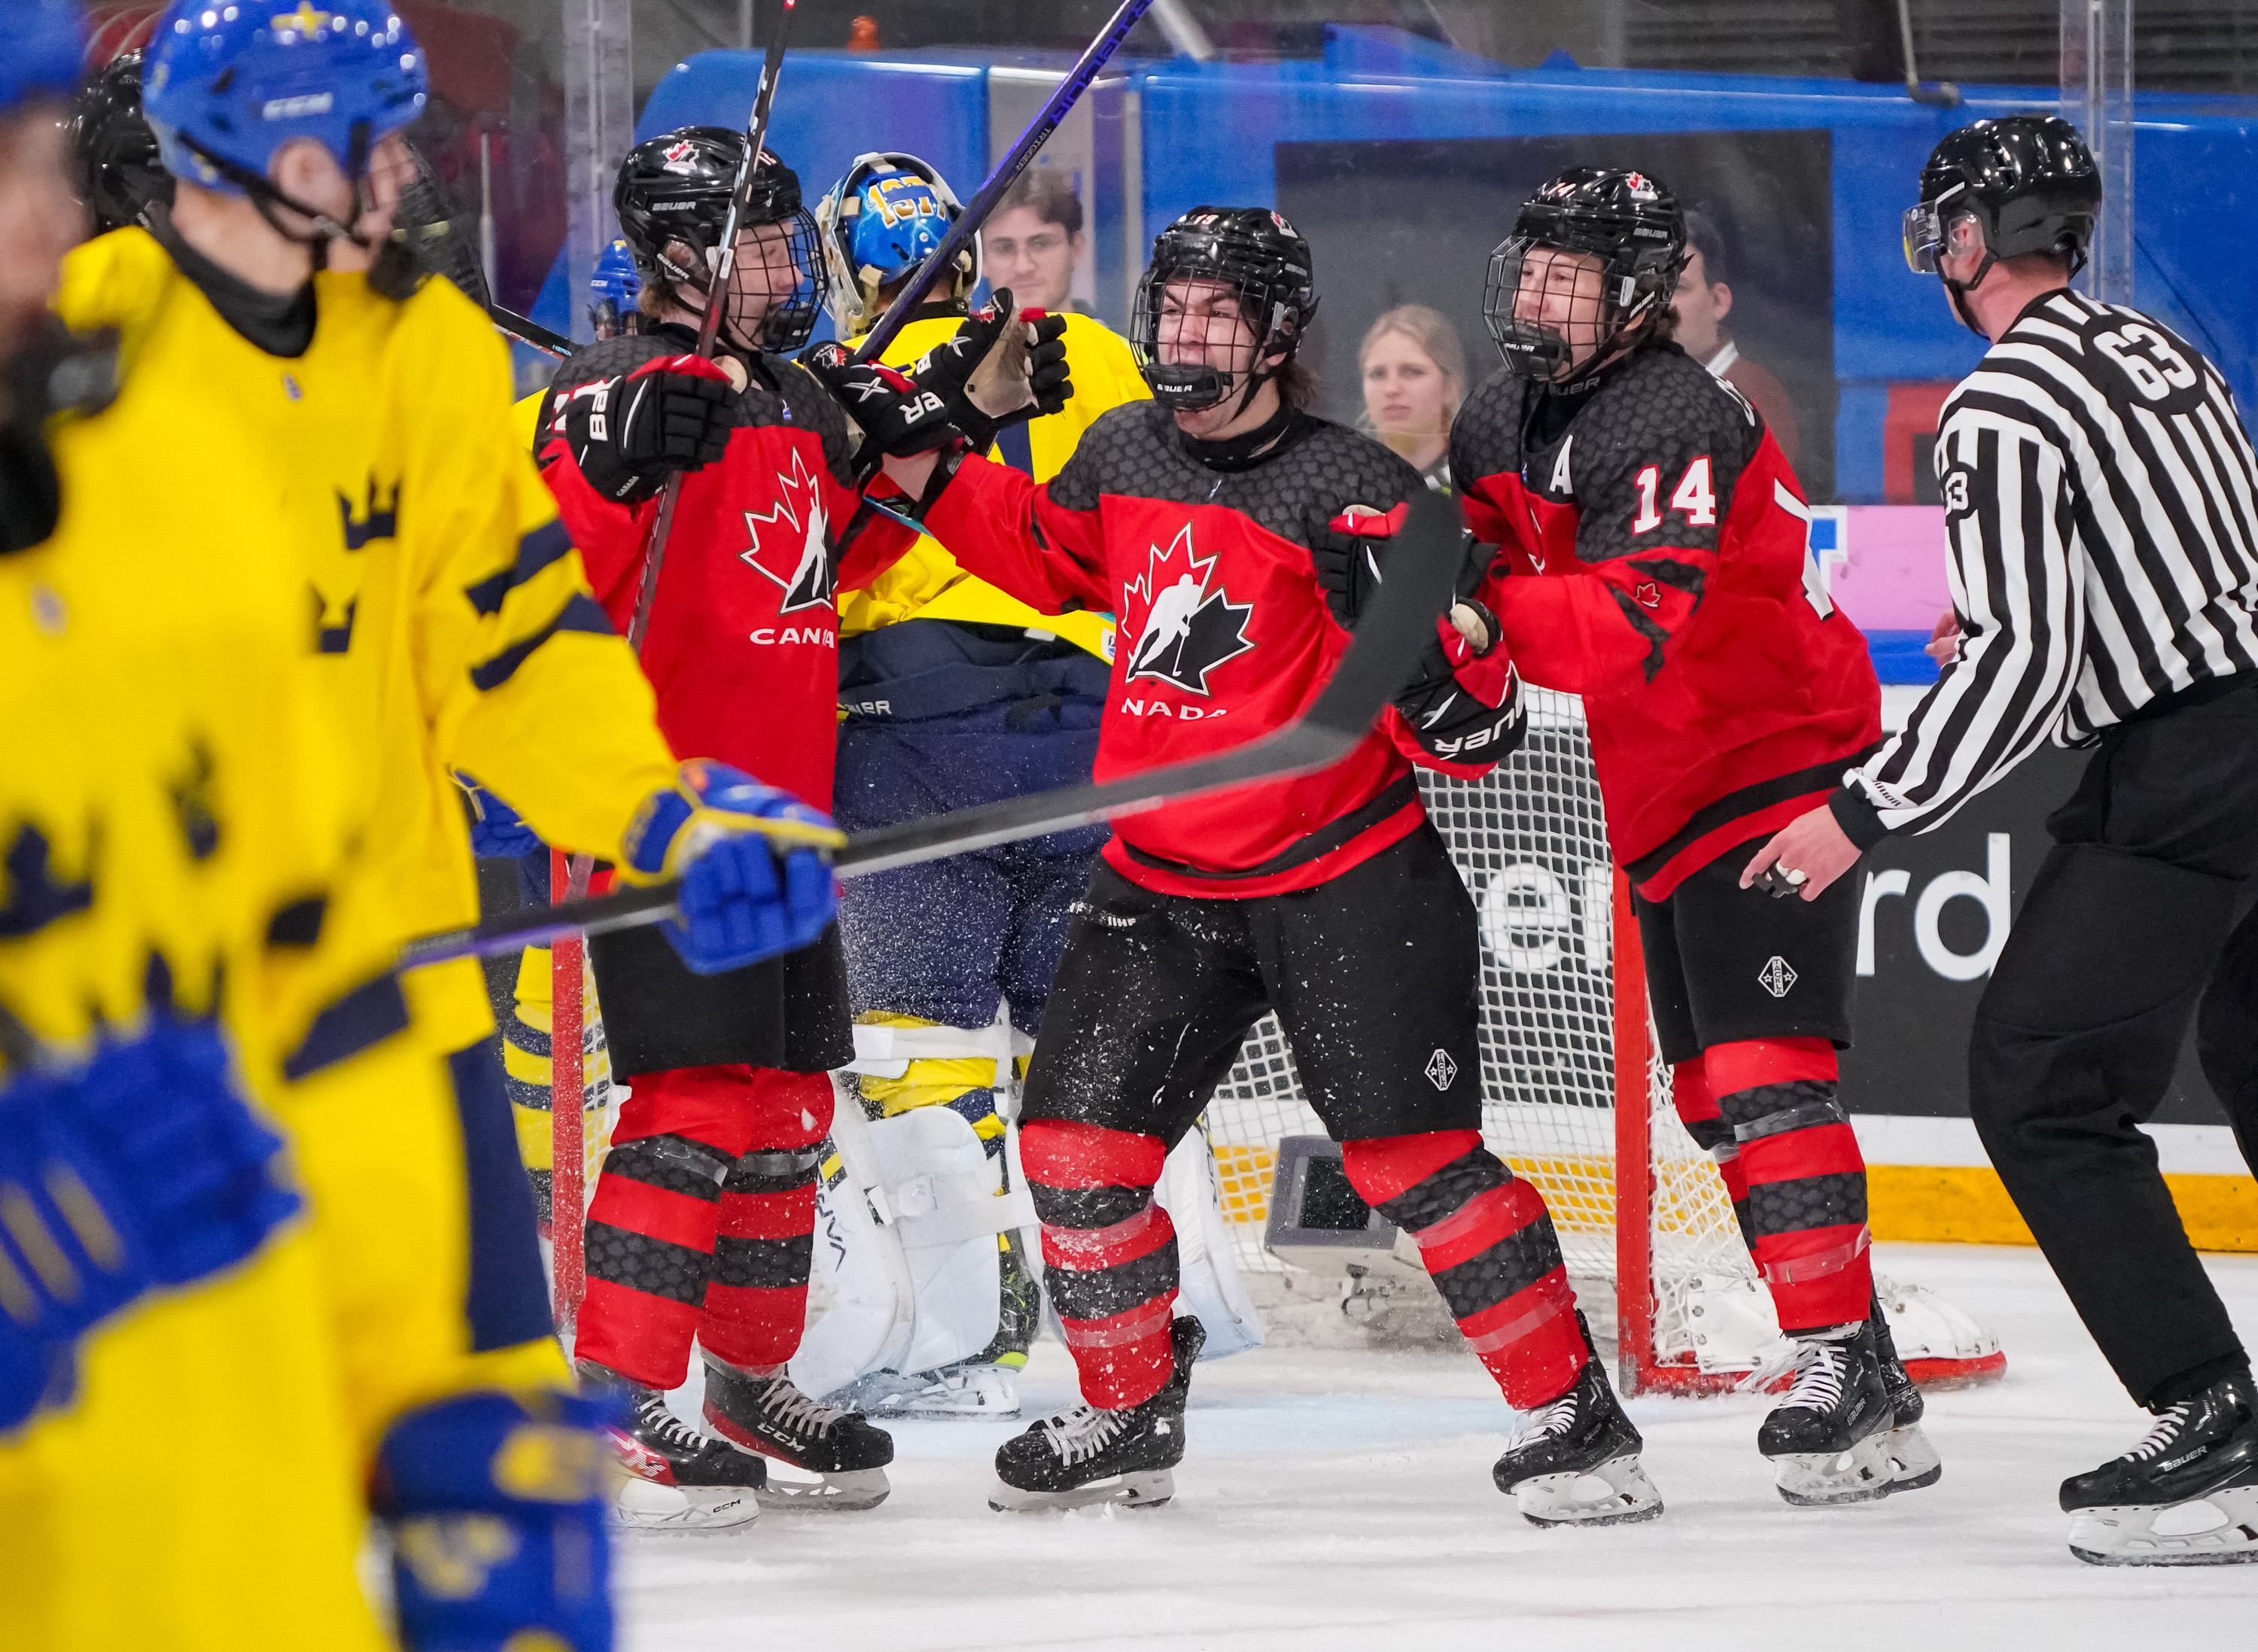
xmin=926 ymin=402 xmax=1488 ymax=898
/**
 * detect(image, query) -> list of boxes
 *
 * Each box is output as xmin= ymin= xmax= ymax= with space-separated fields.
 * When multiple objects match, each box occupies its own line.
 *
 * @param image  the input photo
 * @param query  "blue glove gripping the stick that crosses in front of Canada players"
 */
xmin=619 ymin=761 xmax=847 ymax=975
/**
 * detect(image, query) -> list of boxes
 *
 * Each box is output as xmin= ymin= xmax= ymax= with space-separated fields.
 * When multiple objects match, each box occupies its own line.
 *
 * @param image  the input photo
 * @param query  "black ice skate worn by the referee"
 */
xmin=2062 ymin=1370 xmax=2258 ymax=1566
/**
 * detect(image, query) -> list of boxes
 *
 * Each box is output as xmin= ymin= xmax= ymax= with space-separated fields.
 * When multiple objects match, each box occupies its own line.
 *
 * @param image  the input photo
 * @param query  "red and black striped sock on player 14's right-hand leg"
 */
xmin=1703 ymin=1038 xmax=1874 ymax=1331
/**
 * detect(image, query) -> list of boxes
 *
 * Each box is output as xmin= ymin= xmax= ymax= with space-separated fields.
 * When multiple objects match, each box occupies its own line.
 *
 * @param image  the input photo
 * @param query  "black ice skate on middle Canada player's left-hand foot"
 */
xmin=989 ymin=1316 xmax=1208 ymax=1510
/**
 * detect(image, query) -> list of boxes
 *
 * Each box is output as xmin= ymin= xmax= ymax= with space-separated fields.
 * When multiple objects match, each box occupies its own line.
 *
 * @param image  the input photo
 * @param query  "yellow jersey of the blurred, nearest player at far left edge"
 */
xmin=0 ymin=342 xmax=384 ymax=1652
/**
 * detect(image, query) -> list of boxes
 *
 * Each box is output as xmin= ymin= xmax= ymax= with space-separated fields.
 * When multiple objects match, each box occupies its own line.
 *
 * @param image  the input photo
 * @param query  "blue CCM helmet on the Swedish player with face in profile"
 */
xmin=142 ymin=0 xmax=431 ymax=205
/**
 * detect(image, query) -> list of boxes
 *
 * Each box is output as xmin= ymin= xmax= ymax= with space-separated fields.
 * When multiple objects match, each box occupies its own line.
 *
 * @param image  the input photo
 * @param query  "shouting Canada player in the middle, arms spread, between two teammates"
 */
xmin=849 ymin=208 xmax=1660 ymax=1519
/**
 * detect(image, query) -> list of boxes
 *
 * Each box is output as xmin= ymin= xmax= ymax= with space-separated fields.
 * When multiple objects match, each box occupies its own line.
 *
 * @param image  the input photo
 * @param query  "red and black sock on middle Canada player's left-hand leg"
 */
xmin=1018 ymin=1119 xmax=1176 ymax=1410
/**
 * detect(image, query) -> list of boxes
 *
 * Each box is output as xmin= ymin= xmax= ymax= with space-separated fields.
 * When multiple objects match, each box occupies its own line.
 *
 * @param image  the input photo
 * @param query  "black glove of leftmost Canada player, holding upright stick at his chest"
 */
xmin=551 ymin=357 xmax=736 ymax=506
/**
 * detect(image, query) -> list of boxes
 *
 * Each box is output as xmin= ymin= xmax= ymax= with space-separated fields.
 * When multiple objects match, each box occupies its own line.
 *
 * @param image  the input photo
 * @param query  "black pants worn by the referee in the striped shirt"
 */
xmin=1969 ymin=686 xmax=2258 ymax=1406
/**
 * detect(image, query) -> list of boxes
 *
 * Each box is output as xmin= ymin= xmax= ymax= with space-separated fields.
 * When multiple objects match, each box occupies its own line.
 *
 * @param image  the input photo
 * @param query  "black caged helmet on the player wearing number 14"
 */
xmin=1481 ymin=167 xmax=1687 ymax=379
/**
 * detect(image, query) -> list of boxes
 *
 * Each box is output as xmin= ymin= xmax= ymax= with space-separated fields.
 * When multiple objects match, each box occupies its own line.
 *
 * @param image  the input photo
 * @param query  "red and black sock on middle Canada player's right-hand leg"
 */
xmin=1341 ymin=1130 xmax=1590 ymax=1410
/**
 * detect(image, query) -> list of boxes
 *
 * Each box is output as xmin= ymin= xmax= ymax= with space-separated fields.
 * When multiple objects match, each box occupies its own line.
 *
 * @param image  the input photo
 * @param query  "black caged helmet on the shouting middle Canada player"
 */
xmin=1129 ymin=205 xmax=1316 ymax=411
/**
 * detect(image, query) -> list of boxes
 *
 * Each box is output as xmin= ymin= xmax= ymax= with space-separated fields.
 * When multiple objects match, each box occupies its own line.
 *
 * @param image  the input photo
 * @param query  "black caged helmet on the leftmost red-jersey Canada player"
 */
xmin=612 ymin=126 xmax=822 ymax=354
